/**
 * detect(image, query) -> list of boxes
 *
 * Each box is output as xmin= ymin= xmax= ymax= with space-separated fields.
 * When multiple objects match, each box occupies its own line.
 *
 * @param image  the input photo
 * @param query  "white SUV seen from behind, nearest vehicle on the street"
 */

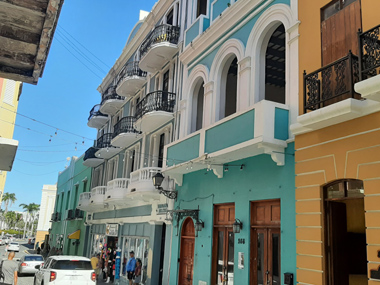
xmin=34 ymin=255 xmax=96 ymax=285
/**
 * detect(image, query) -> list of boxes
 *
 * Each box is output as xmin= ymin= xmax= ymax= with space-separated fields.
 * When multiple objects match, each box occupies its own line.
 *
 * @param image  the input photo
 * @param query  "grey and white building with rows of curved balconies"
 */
xmin=78 ymin=1 xmax=185 ymax=285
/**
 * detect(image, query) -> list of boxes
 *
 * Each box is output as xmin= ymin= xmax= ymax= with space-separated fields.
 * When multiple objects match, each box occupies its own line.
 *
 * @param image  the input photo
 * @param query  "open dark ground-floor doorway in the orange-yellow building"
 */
xmin=324 ymin=180 xmax=368 ymax=285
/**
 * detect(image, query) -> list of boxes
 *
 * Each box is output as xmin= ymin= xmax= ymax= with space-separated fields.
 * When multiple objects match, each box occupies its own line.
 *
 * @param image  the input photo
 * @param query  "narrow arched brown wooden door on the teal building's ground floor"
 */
xmin=178 ymin=218 xmax=195 ymax=285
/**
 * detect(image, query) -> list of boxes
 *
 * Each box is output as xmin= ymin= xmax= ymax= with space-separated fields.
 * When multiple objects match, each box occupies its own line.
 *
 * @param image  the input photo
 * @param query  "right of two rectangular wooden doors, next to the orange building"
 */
xmin=250 ymin=200 xmax=281 ymax=285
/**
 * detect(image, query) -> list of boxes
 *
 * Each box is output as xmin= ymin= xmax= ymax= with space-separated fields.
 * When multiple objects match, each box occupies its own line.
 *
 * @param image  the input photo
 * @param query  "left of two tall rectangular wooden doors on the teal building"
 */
xmin=211 ymin=204 xmax=235 ymax=285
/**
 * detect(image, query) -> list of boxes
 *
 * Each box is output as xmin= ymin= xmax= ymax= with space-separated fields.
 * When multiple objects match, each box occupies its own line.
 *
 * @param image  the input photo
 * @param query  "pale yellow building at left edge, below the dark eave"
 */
xmin=0 ymin=78 xmax=22 ymax=203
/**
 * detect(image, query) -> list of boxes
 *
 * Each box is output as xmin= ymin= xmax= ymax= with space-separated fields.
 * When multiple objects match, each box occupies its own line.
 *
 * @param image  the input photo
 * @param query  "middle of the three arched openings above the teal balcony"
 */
xmin=219 ymin=55 xmax=238 ymax=119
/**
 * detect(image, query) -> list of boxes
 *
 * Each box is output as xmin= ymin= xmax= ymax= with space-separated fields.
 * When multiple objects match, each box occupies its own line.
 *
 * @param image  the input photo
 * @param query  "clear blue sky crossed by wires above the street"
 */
xmin=5 ymin=0 xmax=156 ymax=210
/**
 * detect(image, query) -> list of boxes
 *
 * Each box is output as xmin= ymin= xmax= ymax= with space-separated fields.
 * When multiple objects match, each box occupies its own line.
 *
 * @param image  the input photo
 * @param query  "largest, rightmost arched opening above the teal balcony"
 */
xmin=265 ymin=25 xmax=285 ymax=104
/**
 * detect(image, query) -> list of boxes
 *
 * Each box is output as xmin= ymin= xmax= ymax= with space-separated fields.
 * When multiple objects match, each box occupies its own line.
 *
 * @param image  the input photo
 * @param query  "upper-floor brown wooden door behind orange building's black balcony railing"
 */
xmin=321 ymin=0 xmax=362 ymax=66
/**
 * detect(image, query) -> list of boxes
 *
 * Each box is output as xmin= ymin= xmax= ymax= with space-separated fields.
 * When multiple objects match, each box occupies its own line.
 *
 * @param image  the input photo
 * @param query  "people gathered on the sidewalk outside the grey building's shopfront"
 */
xmin=91 ymin=249 xmax=142 ymax=285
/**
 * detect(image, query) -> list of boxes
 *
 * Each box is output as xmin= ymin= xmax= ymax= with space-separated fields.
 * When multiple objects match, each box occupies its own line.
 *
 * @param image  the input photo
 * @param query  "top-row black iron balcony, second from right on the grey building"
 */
xmin=116 ymin=61 xmax=147 ymax=97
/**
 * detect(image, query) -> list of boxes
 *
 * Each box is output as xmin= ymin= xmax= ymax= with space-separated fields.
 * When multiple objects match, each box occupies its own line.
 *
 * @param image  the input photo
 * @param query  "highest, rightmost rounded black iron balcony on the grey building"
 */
xmin=139 ymin=24 xmax=180 ymax=72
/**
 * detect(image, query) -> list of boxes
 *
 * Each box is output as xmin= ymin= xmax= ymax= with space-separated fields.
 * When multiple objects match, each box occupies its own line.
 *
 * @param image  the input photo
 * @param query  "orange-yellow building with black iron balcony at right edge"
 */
xmin=291 ymin=0 xmax=380 ymax=285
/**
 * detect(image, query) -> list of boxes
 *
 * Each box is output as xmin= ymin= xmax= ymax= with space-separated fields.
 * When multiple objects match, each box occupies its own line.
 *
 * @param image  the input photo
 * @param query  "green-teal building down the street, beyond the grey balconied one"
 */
xmin=49 ymin=155 xmax=91 ymax=256
